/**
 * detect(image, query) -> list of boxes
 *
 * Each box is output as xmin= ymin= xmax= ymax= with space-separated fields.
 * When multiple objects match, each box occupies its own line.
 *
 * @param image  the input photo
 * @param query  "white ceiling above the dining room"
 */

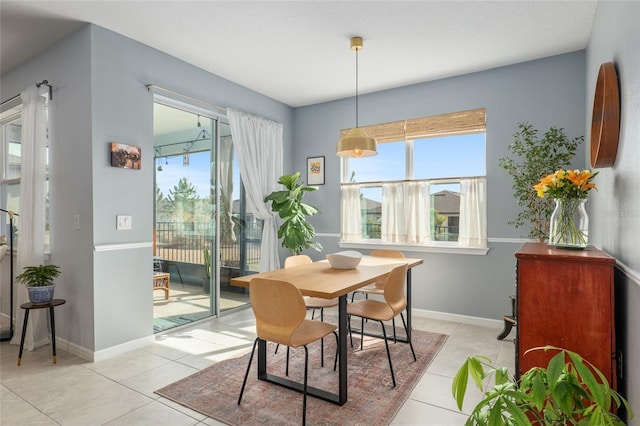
xmin=0 ymin=0 xmax=597 ymax=107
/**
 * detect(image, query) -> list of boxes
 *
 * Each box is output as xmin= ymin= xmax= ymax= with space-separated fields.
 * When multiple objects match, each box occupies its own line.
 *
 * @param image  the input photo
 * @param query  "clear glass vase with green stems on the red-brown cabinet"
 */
xmin=549 ymin=198 xmax=589 ymax=249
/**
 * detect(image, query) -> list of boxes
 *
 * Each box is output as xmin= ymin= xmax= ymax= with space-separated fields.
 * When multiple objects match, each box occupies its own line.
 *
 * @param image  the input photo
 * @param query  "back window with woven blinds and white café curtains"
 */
xmin=341 ymin=109 xmax=486 ymax=248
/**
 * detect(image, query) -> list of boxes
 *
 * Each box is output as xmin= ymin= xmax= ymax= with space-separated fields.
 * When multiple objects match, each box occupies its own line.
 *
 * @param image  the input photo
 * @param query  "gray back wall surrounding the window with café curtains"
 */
xmin=292 ymin=51 xmax=585 ymax=320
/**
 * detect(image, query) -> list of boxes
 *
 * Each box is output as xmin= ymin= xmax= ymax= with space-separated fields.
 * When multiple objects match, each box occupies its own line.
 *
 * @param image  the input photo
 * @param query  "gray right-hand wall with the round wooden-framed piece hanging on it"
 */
xmin=585 ymin=1 xmax=640 ymax=425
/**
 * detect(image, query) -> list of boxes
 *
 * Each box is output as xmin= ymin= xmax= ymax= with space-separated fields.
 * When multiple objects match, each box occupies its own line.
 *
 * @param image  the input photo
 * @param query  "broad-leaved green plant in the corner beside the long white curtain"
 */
xmin=264 ymin=172 xmax=322 ymax=255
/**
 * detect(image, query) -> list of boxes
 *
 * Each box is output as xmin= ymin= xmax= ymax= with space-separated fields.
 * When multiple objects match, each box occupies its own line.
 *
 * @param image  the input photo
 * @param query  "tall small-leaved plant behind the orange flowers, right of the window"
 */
xmin=498 ymin=123 xmax=584 ymax=242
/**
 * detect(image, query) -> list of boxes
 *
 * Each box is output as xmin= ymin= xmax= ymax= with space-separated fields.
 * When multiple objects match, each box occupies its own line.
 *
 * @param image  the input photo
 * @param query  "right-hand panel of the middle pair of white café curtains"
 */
xmin=404 ymin=181 xmax=431 ymax=244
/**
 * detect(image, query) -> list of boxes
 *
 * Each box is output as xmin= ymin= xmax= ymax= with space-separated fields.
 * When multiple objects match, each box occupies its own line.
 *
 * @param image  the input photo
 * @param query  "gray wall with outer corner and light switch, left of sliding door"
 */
xmin=2 ymin=25 xmax=293 ymax=357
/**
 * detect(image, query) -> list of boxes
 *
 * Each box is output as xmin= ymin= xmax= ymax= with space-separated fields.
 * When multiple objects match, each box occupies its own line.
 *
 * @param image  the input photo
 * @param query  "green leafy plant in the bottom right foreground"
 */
xmin=451 ymin=346 xmax=633 ymax=426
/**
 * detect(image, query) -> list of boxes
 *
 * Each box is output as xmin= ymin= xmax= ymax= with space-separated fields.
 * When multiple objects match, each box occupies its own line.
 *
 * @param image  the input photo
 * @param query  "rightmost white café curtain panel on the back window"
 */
xmin=458 ymin=178 xmax=487 ymax=248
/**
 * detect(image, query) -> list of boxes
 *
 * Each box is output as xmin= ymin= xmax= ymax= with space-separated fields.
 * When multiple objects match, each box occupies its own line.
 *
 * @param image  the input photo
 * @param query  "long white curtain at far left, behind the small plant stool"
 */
xmin=11 ymin=85 xmax=50 ymax=351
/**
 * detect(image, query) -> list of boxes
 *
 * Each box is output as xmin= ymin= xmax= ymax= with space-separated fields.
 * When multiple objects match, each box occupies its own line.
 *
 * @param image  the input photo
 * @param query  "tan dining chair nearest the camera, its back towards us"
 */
xmin=238 ymin=278 xmax=338 ymax=425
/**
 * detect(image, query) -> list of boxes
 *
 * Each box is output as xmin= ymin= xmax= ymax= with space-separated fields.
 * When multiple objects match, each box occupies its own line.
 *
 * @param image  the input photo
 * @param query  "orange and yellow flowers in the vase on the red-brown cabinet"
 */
xmin=533 ymin=169 xmax=598 ymax=199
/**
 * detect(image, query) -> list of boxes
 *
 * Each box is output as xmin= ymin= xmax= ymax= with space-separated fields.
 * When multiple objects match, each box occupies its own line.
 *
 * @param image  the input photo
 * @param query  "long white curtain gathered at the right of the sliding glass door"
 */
xmin=227 ymin=109 xmax=283 ymax=272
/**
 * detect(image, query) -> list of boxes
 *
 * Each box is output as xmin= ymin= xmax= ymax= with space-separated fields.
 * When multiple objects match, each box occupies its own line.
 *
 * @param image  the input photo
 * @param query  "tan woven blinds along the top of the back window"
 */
xmin=340 ymin=108 xmax=486 ymax=143
